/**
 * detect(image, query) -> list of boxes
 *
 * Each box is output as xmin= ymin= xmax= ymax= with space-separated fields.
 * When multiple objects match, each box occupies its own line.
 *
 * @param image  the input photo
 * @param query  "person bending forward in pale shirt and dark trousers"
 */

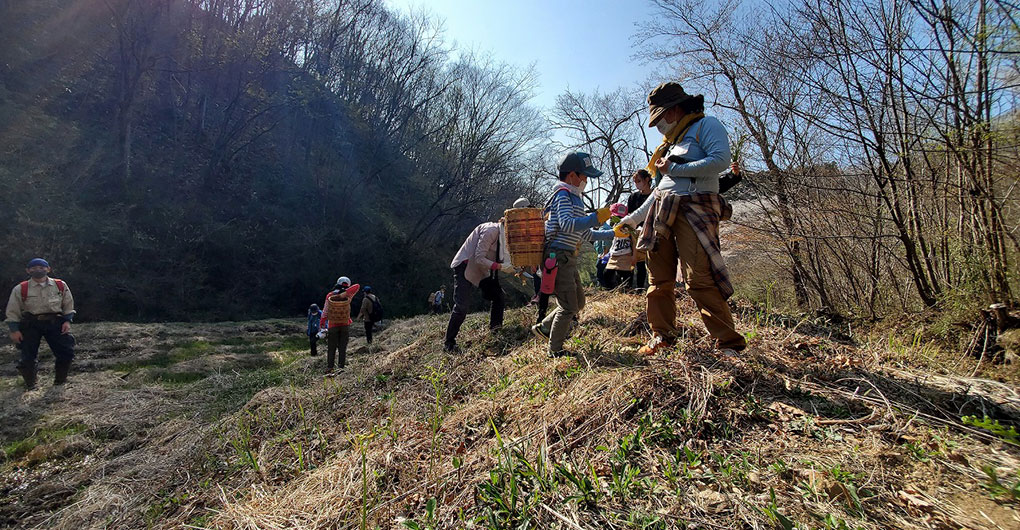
xmin=443 ymin=204 xmax=511 ymax=353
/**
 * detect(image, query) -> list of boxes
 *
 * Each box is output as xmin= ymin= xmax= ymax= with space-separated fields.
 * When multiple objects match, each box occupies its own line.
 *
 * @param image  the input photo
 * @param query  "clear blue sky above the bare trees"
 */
xmin=387 ymin=0 xmax=652 ymax=108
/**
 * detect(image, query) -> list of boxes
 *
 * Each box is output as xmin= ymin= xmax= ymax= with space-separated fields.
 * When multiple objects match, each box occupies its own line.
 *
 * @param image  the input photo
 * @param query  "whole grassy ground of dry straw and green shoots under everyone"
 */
xmin=0 ymin=294 xmax=1020 ymax=528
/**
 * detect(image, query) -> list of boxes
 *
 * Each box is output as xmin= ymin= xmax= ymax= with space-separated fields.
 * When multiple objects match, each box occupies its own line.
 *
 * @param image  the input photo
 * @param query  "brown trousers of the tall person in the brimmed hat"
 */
xmin=648 ymin=213 xmax=747 ymax=350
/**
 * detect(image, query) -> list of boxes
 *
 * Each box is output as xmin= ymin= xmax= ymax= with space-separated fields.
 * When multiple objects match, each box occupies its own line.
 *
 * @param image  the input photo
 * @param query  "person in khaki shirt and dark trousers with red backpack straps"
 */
xmin=7 ymin=258 xmax=74 ymax=390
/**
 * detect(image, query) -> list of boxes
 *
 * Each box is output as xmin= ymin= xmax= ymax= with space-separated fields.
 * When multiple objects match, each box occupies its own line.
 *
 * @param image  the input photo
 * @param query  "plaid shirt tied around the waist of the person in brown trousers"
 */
xmin=638 ymin=190 xmax=733 ymax=299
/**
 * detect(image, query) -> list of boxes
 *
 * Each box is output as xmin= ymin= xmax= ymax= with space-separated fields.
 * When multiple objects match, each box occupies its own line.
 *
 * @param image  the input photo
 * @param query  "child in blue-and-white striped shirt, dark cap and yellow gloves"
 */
xmin=531 ymin=152 xmax=613 ymax=357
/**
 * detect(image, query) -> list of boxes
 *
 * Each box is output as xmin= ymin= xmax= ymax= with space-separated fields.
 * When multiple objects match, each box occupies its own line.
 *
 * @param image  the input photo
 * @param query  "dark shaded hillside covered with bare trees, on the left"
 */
xmin=0 ymin=0 xmax=548 ymax=320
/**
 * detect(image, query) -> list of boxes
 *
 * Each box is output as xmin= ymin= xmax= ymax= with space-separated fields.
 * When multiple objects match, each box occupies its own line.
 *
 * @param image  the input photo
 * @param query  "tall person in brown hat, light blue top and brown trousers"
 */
xmin=617 ymin=83 xmax=747 ymax=356
